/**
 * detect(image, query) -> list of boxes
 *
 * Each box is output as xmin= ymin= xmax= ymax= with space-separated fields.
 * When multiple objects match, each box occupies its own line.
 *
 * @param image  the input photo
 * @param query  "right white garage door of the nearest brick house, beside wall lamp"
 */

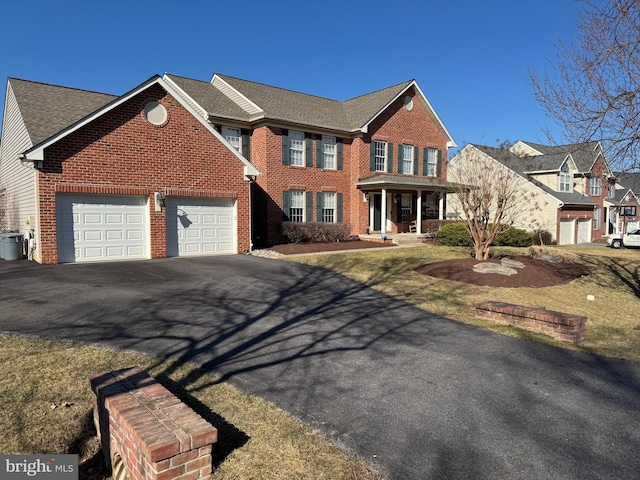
xmin=166 ymin=198 xmax=237 ymax=257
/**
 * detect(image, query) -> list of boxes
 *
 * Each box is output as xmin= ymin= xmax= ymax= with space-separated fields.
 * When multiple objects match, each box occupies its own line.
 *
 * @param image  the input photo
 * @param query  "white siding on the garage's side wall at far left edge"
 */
xmin=0 ymin=82 xmax=36 ymax=234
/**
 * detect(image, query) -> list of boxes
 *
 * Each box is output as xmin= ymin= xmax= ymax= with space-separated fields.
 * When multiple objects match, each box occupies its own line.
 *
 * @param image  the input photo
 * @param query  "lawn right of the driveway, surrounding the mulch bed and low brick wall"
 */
xmin=287 ymin=246 xmax=640 ymax=362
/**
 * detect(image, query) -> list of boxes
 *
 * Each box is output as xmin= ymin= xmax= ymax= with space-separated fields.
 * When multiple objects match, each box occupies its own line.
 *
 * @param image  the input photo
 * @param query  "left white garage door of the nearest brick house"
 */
xmin=56 ymin=194 xmax=149 ymax=263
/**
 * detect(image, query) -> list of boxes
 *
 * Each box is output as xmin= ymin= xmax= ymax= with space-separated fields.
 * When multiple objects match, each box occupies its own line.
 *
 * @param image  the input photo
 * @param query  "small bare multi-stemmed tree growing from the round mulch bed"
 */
xmin=447 ymin=145 xmax=540 ymax=260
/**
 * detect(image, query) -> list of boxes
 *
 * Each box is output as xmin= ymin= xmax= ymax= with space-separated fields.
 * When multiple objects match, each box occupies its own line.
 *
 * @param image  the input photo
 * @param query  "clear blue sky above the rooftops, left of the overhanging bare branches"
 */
xmin=0 ymin=0 xmax=580 ymax=154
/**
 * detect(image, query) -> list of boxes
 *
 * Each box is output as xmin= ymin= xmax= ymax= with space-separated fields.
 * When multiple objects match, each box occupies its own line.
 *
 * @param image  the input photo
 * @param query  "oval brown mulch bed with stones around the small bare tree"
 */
xmin=415 ymin=256 xmax=591 ymax=288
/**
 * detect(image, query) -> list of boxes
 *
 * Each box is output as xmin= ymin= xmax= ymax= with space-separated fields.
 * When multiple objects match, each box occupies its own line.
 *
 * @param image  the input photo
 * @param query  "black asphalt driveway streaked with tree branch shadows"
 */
xmin=0 ymin=256 xmax=640 ymax=480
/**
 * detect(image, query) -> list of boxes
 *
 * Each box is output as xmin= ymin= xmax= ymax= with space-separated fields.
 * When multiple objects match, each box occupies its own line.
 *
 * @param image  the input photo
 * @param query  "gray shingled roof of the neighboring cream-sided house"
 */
xmin=473 ymin=143 xmax=597 ymax=205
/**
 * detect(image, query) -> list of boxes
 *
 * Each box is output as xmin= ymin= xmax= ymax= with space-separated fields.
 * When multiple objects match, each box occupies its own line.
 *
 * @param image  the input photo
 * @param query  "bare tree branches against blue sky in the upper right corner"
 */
xmin=531 ymin=0 xmax=640 ymax=171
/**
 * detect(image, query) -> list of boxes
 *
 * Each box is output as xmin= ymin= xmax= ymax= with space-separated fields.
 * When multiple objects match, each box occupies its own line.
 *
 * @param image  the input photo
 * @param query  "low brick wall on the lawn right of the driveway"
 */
xmin=475 ymin=301 xmax=587 ymax=345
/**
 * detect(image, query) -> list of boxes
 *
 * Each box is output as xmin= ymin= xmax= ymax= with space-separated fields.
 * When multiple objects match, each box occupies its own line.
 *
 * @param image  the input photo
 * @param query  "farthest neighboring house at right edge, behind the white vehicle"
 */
xmin=609 ymin=172 xmax=640 ymax=234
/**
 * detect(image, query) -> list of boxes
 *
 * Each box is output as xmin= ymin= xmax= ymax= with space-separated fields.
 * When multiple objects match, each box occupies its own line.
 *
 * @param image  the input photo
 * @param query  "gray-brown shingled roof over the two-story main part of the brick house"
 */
xmin=170 ymin=73 xmax=413 ymax=132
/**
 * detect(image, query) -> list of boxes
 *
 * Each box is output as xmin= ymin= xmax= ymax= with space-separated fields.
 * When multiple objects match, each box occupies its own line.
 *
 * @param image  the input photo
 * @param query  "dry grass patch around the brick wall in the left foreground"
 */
xmin=0 ymin=336 xmax=382 ymax=480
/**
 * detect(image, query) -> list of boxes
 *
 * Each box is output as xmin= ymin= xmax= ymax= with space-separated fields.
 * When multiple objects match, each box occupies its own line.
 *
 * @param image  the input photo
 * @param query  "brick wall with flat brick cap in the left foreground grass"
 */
xmin=89 ymin=367 xmax=218 ymax=480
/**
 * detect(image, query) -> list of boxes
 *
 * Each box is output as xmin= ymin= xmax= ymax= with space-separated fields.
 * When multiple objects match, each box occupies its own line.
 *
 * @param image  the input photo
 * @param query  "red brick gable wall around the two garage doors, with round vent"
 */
xmin=38 ymin=85 xmax=250 ymax=263
